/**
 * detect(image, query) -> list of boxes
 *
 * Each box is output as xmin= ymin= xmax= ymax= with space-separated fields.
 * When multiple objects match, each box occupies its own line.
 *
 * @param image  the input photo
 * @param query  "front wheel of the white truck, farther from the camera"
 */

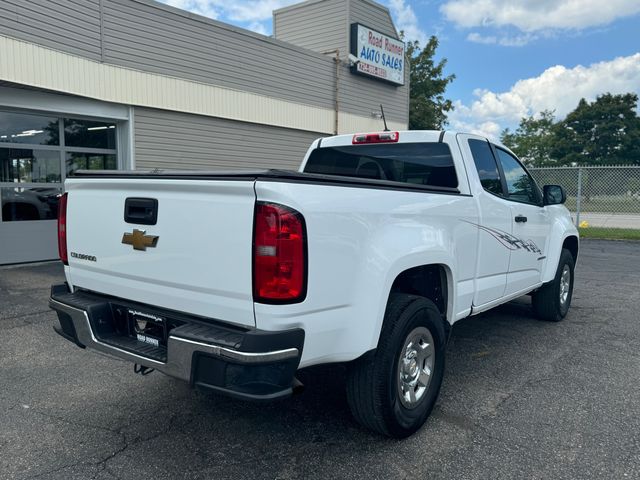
xmin=531 ymin=248 xmax=575 ymax=322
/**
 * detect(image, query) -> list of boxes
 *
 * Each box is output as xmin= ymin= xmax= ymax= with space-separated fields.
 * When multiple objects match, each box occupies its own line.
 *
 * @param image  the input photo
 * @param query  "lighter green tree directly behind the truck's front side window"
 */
xmin=500 ymin=110 xmax=557 ymax=167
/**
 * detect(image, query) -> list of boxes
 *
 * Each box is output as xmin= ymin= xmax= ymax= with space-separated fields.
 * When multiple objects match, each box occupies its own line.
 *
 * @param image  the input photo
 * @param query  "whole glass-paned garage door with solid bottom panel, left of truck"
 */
xmin=0 ymin=110 xmax=118 ymax=265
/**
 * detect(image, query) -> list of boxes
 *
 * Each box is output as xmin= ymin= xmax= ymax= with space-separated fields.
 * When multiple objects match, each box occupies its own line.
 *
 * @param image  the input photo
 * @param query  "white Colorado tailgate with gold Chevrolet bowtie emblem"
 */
xmin=66 ymin=178 xmax=255 ymax=327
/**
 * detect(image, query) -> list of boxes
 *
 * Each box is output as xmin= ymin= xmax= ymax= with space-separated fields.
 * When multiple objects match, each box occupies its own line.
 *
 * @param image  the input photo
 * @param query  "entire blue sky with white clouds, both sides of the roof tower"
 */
xmin=161 ymin=0 xmax=640 ymax=137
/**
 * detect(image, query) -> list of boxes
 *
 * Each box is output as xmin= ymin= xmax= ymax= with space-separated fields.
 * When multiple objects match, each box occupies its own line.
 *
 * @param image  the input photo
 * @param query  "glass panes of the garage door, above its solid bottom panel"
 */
xmin=0 ymin=111 xmax=118 ymax=222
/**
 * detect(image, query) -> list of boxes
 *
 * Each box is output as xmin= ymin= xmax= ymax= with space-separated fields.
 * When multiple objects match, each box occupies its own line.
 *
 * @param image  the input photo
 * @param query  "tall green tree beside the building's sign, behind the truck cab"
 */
xmin=401 ymin=33 xmax=455 ymax=130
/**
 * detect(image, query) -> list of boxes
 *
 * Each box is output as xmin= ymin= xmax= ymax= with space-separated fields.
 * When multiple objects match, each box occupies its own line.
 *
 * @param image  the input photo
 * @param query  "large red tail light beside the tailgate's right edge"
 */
xmin=253 ymin=202 xmax=307 ymax=303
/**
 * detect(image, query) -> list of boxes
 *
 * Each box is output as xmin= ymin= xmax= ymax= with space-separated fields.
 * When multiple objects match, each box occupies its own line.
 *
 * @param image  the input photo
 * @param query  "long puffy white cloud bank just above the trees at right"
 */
xmin=449 ymin=53 xmax=640 ymax=138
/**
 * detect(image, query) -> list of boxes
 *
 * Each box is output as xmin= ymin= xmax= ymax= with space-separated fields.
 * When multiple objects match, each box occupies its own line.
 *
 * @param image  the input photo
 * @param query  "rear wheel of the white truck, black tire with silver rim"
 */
xmin=347 ymin=294 xmax=446 ymax=438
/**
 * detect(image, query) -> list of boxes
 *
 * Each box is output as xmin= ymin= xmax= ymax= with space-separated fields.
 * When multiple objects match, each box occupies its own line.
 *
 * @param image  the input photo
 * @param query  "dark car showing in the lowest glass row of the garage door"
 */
xmin=0 ymin=187 xmax=61 ymax=222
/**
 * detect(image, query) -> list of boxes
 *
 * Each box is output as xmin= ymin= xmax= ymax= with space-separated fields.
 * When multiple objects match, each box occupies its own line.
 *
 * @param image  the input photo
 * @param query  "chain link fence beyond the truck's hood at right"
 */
xmin=529 ymin=166 xmax=640 ymax=231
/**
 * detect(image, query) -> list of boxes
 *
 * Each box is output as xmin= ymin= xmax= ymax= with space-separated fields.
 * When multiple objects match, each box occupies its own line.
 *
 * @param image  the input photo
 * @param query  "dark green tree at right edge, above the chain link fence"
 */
xmin=554 ymin=93 xmax=640 ymax=165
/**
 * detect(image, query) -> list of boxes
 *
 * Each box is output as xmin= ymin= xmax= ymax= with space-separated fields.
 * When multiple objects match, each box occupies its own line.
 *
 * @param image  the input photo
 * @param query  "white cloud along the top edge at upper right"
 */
xmin=440 ymin=0 xmax=640 ymax=32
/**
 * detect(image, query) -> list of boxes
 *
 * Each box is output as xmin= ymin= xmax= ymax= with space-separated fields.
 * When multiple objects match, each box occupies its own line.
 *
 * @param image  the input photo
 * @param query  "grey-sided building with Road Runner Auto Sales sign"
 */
xmin=0 ymin=0 xmax=409 ymax=264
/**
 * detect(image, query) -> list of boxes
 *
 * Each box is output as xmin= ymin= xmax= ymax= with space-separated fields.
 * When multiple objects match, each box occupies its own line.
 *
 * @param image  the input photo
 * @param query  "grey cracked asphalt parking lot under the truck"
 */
xmin=0 ymin=241 xmax=640 ymax=479
